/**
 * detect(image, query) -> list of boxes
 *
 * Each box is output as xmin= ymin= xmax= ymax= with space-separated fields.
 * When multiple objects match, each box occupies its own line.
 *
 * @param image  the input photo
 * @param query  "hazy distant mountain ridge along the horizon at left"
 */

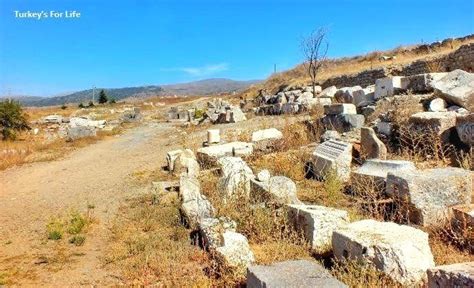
xmin=0 ymin=78 xmax=260 ymax=106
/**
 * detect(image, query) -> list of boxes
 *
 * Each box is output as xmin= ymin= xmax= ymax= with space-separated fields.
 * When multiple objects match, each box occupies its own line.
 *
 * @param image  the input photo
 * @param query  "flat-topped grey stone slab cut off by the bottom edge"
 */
xmin=247 ymin=260 xmax=347 ymax=288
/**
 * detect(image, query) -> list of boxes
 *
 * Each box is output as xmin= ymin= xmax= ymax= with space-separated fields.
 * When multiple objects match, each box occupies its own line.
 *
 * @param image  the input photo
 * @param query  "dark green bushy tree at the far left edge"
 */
xmin=0 ymin=100 xmax=30 ymax=141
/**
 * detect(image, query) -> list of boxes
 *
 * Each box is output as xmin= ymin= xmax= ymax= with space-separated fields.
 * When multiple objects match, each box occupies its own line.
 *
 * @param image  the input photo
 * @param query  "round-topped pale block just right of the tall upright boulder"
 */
xmin=251 ymin=176 xmax=301 ymax=205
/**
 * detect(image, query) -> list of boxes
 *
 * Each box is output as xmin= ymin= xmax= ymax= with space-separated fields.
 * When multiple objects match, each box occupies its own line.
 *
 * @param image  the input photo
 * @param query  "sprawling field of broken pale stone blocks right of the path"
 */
xmin=157 ymin=70 xmax=474 ymax=287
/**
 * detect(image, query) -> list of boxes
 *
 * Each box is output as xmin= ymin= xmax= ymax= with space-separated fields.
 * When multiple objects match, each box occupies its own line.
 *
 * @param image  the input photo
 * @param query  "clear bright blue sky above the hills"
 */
xmin=0 ymin=0 xmax=474 ymax=96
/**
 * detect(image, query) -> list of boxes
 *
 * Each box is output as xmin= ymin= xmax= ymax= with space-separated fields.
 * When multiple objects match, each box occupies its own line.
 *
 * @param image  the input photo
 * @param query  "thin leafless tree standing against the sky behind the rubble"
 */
xmin=301 ymin=28 xmax=329 ymax=97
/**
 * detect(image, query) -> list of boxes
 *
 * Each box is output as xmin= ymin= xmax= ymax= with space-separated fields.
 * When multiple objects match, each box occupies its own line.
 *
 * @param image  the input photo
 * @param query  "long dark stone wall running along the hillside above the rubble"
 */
xmin=321 ymin=43 xmax=474 ymax=88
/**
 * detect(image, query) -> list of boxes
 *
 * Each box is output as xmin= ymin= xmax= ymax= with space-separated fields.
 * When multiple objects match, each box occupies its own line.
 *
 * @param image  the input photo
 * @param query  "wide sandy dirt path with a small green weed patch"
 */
xmin=0 ymin=123 xmax=181 ymax=287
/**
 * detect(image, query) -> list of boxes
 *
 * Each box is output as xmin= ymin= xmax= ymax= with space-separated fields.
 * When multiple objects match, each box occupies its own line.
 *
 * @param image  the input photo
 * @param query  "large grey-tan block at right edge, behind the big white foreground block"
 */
xmin=387 ymin=168 xmax=472 ymax=226
